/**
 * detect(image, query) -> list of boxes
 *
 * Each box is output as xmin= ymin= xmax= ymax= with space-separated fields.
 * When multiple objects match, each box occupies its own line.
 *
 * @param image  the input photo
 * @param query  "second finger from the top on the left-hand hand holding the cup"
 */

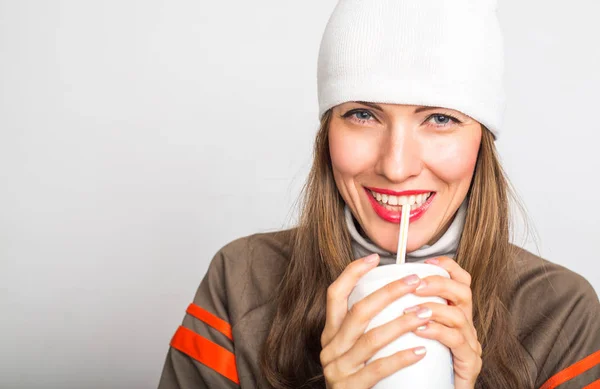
xmin=321 ymin=274 xmax=420 ymax=366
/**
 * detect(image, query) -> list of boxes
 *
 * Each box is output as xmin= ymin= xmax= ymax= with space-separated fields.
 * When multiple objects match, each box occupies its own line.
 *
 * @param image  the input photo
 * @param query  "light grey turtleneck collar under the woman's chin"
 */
xmin=344 ymin=199 xmax=468 ymax=266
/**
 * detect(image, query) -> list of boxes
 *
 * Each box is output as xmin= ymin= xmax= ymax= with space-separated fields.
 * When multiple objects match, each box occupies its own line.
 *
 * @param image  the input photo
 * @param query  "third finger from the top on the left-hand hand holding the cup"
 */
xmin=334 ymin=306 xmax=429 ymax=372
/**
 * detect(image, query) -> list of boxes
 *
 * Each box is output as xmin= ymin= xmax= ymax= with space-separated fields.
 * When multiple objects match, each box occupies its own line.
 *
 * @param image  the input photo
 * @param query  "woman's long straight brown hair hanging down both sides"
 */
xmin=260 ymin=110 xmax=533 ymax=389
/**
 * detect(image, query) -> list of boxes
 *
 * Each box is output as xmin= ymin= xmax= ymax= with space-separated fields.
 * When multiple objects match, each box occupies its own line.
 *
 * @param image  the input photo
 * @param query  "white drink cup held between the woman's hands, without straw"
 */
xmin=348 ymin=263 xmax=454 ymax=389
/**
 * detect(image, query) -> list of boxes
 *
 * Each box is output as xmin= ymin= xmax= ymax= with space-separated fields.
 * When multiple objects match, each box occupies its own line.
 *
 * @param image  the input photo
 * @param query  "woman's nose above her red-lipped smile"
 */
xmin=375 ymin=128 xmax=423 ymax=183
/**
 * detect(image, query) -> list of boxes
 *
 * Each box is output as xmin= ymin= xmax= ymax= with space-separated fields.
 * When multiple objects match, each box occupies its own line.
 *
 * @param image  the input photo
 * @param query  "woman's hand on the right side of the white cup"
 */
xmin=409 ymin=257 xmax=482 ymax=389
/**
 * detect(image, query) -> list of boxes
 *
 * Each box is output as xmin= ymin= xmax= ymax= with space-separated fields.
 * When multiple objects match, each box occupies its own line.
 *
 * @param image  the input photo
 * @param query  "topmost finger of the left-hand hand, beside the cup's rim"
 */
xmin=321 ymin=254 xmax=379 ymax=347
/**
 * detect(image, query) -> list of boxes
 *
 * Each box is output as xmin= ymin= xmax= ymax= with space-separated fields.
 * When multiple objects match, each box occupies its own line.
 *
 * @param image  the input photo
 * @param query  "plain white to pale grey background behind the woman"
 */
xmin=0 ymin=0 xmax=600 ymax=389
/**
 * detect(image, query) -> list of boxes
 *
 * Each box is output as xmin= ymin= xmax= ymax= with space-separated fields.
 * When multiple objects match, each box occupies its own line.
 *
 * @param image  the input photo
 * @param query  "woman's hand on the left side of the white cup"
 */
xmin=320 ymin=254 xmax=431 ymax=389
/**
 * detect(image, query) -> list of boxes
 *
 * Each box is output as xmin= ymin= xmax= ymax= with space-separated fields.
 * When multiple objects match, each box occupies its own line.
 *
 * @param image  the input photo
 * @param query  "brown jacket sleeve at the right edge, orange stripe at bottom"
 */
xmin=522 ymin=264 xmax=600 ymax=389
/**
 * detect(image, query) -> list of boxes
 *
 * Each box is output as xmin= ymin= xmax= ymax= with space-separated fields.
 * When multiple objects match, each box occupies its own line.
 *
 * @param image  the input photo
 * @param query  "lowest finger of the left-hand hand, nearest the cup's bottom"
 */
xmin=347 ymin=347 xmax=426 ymax=388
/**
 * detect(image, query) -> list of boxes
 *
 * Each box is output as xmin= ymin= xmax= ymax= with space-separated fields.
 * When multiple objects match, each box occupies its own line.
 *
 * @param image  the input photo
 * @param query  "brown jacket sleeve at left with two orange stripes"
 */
xmin=158 ymin=251 xmax=240 ymax=389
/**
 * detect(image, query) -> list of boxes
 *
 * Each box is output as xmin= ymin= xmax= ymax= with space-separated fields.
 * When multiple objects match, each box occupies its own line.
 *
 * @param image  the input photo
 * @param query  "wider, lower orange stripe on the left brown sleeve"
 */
xmin=171 ymin=326 xmax=240 ymax=385
